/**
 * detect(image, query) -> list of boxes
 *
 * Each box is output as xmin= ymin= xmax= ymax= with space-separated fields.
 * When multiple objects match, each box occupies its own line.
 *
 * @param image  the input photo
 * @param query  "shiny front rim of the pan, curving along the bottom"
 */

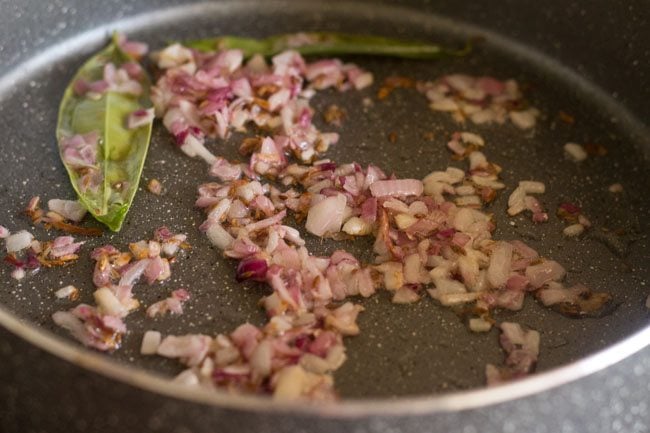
xmin=0 ymin=307 xmax=650 ymax=418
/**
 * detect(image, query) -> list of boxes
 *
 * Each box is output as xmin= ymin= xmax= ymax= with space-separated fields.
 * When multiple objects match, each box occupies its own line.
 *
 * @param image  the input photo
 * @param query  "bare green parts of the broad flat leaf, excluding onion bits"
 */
xmin=56 ymin=35 xmax=153 ymax=231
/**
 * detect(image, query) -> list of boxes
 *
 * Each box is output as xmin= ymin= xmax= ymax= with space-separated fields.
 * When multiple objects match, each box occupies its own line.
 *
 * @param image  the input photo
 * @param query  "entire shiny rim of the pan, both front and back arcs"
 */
xmin=0 ymin=1 xmax=650 ymax=418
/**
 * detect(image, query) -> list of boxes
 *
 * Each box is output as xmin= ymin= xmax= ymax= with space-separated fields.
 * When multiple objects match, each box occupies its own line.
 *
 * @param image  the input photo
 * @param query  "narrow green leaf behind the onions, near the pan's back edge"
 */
xmin=183 ymin=32 xmax=471 ymax=59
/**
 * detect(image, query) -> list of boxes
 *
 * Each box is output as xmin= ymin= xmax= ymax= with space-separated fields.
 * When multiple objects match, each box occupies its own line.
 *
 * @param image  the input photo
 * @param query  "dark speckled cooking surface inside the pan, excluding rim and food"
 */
xmin=0 ymin=2 xmax=650 ymax=398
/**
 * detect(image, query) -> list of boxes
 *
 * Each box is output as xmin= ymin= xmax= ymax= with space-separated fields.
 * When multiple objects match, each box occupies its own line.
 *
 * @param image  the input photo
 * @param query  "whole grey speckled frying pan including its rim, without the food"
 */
xmin=0 ymin=0 xmax=650 ymax=433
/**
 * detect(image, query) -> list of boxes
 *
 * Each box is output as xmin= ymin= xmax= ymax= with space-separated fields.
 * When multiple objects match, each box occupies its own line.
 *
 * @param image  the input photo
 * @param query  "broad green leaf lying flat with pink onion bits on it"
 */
xmin=56 ymin=36 xmax=153 ymax=231
